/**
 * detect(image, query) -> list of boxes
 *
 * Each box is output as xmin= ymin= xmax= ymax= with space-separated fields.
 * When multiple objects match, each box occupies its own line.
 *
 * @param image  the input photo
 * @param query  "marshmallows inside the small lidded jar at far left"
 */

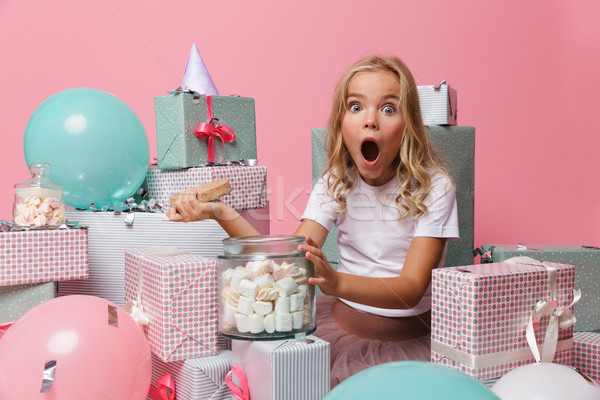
xmin=13 ymin=196 xmax=65 ymax=227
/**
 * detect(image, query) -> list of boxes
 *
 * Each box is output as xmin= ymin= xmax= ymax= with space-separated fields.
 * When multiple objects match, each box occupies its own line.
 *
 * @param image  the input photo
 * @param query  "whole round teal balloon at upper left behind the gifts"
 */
xmin=23 ymin=88 xmax=150 ymax=208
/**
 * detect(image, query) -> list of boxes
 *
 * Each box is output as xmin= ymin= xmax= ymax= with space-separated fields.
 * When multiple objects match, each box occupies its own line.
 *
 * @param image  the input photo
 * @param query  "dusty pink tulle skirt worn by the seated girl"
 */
xmin=314 ymin=295 xmax=431 ymax=389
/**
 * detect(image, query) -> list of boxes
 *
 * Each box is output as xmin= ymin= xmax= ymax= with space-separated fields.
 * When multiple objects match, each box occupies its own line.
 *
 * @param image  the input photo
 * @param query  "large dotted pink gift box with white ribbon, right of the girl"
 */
xmin=431 ymin=262 xmax=574 ymax=381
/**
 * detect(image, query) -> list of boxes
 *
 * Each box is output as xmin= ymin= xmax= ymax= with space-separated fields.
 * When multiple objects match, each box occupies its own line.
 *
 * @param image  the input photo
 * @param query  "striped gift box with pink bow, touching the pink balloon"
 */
xmin=148 ymin=350 xmax=232 ymax=400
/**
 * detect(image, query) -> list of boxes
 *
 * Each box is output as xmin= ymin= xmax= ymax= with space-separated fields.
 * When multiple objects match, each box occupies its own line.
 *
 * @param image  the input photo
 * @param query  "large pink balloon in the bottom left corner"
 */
xmin=0 ymin=296 xmax=152 ymax=400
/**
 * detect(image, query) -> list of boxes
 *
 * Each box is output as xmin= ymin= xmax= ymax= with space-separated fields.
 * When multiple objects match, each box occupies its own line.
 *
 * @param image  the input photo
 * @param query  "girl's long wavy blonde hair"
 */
xmin=323 ymin=56 xmax=448 ymax=218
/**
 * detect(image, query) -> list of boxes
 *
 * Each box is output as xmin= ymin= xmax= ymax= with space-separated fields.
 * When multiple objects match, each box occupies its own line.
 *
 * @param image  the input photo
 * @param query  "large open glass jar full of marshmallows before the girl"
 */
xmin=217 ymin=236 xmax=317 ymax=340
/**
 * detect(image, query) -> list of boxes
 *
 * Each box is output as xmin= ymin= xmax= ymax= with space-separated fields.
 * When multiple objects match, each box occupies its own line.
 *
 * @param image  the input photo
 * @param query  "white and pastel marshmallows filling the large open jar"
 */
xmin=221 ymin=260 xmax=312 ymax=334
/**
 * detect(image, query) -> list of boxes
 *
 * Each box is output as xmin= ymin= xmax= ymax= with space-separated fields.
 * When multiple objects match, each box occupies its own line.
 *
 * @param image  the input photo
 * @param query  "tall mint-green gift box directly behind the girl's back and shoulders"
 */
xmin=312 ymin=126 xmax=475 ymax=267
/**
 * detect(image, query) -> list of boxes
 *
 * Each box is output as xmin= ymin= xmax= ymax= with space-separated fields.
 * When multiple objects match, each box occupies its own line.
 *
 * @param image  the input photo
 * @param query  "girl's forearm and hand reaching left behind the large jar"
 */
xmin=167 ymin=189 xmax=260 ymax=237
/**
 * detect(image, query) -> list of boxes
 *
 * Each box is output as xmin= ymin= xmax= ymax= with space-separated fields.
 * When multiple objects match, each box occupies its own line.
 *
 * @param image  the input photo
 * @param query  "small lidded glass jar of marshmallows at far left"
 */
xmin=13 ymin=162 xmax=65 ymax=229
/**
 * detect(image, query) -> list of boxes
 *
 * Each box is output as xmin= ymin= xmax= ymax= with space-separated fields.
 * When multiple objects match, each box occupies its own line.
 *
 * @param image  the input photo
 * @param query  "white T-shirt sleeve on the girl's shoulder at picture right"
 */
xmin=414 ymin=173 xmax=459 ymax=239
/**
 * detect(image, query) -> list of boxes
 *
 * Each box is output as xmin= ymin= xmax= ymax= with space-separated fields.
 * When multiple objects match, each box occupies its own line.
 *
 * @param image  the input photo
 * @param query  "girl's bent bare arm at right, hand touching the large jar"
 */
xmin=300 ymin=236 xmax=446 ymax=309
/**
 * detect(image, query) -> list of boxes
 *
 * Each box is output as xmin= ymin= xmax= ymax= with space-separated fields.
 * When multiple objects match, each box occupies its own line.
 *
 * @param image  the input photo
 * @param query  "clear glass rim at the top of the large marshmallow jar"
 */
xmin=223 ymin=235 xmax=304 ymax=257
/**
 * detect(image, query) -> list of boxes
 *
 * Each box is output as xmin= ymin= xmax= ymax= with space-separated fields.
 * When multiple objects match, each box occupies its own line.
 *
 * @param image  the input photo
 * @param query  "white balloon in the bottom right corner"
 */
xmin=492 ymin=363 xmax=600 ymax=400
